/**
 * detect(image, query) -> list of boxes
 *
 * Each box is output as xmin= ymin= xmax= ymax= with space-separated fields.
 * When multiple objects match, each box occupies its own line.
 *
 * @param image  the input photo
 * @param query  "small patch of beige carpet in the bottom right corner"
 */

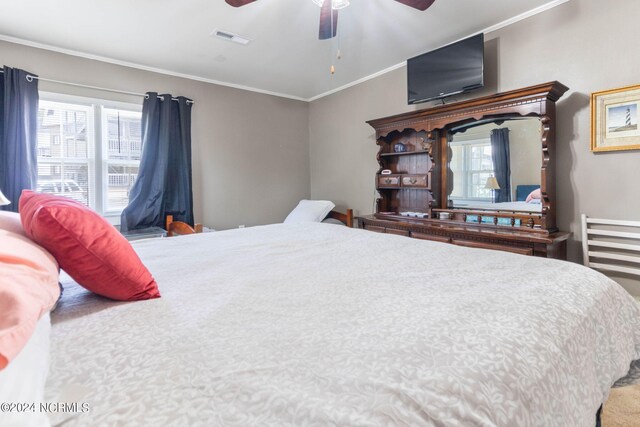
xmin=602 ymin=384 xmax=640 ymax=427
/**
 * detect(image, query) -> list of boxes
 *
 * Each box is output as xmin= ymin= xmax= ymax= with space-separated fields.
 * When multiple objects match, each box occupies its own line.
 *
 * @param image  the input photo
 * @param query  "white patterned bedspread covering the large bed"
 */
xmin=47 ymin=224 xmax=640 ymax=427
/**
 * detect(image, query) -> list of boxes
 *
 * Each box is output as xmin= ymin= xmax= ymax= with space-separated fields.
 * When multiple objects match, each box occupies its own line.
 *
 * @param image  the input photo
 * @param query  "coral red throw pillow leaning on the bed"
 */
xmin=19 ymin=190 xmax=160 ymax=301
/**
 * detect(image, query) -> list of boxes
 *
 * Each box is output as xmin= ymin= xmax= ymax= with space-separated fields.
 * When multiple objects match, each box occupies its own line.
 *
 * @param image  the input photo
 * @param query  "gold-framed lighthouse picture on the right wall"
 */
xmin=591 ymin=85 xmax=640 ymax=152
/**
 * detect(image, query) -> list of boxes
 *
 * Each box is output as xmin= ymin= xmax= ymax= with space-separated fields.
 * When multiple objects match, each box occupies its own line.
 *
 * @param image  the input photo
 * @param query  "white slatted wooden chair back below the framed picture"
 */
xmin=581 ymin=214 xmax=640 ymax=276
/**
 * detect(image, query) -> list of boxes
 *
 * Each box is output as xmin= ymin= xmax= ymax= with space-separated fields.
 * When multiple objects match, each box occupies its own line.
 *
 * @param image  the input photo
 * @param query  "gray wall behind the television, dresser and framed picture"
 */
xmin=309 ymin=0 xmax=640 ymax=295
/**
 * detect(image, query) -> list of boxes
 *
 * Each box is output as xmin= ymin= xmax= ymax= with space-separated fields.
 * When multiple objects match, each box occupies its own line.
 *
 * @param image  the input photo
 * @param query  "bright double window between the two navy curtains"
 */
xmin=37 ymin=95 xmax=142 ymax=216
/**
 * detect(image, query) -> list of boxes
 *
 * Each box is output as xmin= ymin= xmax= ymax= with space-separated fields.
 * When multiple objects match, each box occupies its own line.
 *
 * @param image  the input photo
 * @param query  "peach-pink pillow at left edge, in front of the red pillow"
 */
xmin=0 ymin=230 xmax=60 ymax=370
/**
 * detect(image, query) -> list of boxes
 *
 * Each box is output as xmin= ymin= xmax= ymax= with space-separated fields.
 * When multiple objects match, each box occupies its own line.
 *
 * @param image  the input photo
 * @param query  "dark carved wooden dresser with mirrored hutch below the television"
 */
xmin=358 ymin=82 xmax=570 ymax=259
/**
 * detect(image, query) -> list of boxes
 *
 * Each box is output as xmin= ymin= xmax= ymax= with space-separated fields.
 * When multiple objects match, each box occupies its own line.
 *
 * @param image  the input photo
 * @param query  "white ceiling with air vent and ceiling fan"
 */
xmin=0 ymin=0 xmax=567 ymax=100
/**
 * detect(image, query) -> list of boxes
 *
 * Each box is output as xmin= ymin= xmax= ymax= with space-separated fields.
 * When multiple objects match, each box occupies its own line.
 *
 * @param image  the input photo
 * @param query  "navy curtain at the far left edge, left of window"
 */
xmin=0 ymin=66 xmax=38 ymax=212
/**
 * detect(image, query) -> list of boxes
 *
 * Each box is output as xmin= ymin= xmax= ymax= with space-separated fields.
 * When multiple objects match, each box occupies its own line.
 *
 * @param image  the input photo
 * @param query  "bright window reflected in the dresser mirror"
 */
xmin=451 ymin=139 xmax=493 ymax=201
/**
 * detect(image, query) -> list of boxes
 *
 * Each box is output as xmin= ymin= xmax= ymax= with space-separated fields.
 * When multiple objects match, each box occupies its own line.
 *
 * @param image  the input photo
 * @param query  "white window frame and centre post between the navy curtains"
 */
xmin=38 ymin=91 xmax=142 ymax=225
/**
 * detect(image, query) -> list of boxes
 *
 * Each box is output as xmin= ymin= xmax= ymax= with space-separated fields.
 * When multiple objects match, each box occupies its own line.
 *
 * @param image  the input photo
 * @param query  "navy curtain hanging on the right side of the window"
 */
xmin=120 ymin=92 xmax=193 ymax=231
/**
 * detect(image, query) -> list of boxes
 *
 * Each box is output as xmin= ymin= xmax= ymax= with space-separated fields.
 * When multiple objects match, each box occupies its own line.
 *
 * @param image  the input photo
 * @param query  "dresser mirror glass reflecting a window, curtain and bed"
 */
xmin=449 ymin=117 xmax=542 ymax=213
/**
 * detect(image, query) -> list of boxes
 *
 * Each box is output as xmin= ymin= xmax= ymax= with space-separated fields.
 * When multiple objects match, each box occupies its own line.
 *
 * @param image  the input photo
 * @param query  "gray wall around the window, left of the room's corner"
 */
xmin=0 ymin=42 xmax=310 ymax=229
